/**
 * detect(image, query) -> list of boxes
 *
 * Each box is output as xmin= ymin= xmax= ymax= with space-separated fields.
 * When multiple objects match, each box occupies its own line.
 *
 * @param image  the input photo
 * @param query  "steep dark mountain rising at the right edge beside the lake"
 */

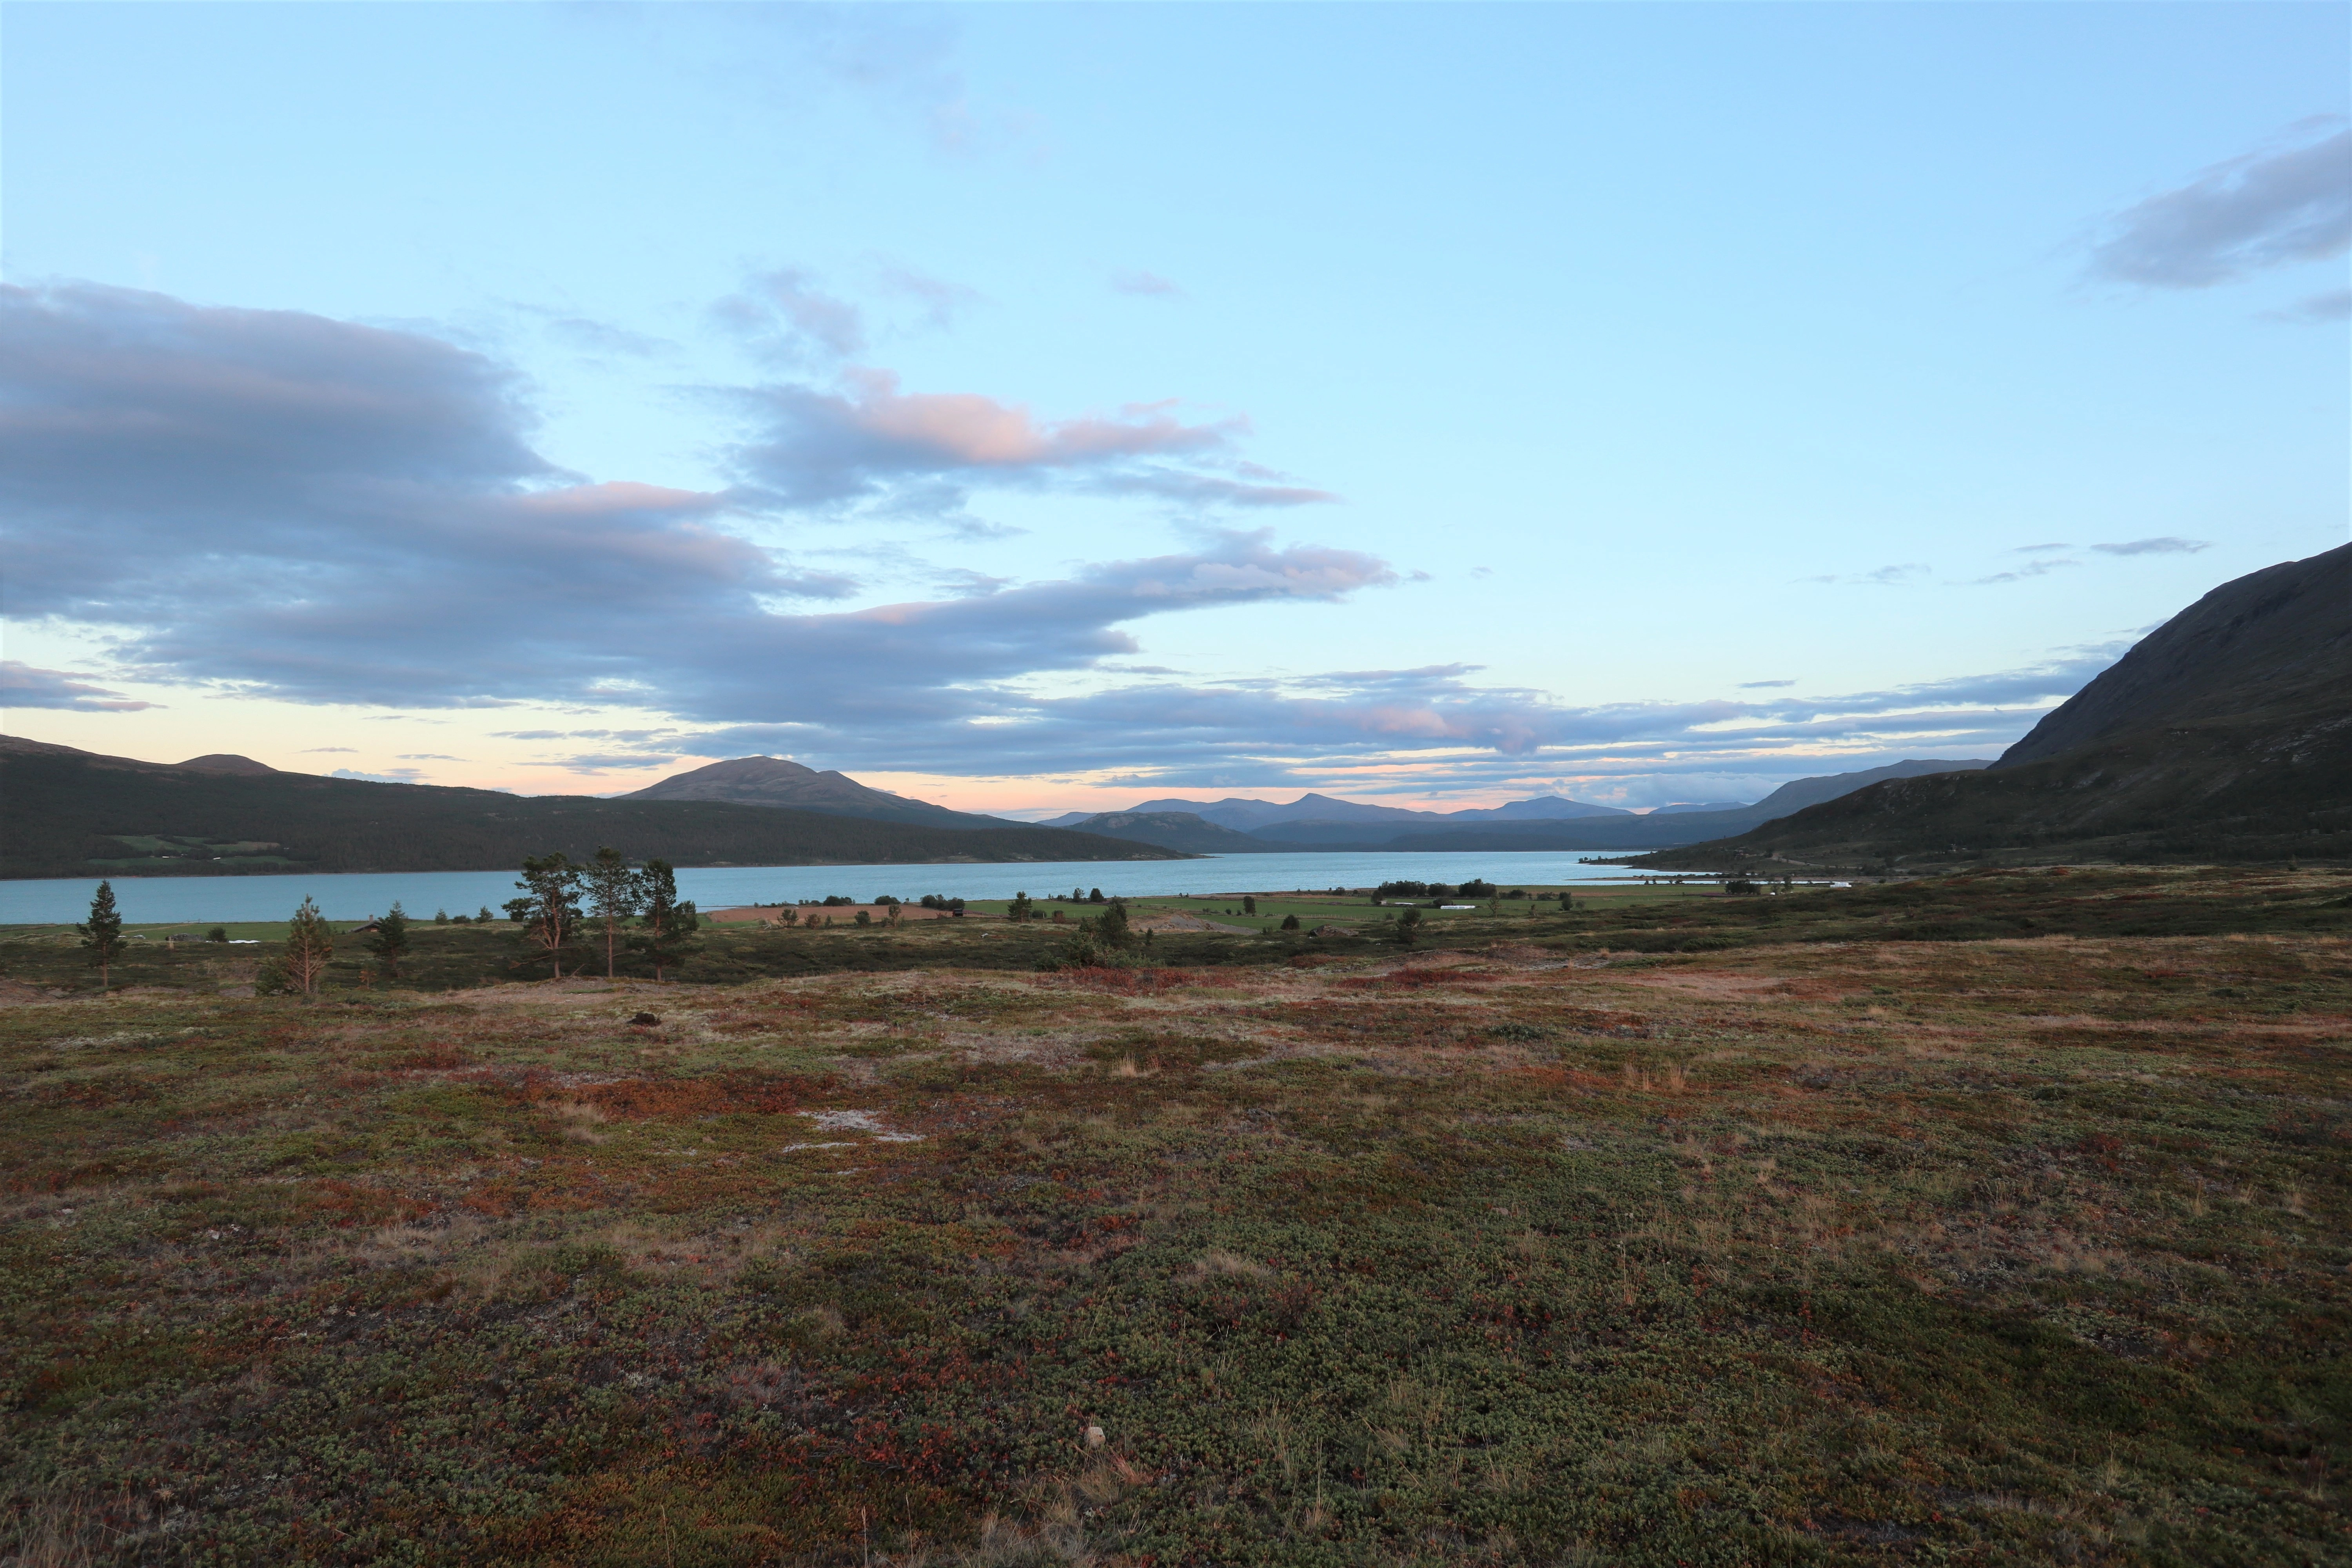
xmin=1656 ymin=545 xmax=2352 ymax=865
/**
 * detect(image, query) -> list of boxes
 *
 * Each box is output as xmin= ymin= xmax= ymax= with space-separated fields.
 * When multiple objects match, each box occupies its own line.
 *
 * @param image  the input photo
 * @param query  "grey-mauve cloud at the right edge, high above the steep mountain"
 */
xmin=2091 ymin=129 xmax=2352 ymax=289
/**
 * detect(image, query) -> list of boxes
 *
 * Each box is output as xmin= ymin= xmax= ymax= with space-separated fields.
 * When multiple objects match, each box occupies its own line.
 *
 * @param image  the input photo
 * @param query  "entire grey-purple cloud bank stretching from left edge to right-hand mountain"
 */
xmin=0 ymin=287 xmax=2112 ymax=785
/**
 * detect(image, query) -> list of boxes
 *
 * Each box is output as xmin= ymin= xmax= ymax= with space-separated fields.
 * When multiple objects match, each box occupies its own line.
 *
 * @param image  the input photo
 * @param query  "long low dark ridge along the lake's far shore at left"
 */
xmin=0 ymin=736 xmax=1181 ymax=877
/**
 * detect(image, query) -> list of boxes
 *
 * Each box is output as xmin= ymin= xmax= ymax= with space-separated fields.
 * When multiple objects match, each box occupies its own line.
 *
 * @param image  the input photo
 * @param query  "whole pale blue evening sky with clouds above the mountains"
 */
xmin=0 ymin=2 xmax=2352 ymax=816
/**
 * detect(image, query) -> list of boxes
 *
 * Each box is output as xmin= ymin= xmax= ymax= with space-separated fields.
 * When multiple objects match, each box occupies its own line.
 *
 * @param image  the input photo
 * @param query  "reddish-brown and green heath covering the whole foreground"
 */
xmin=0 ymin=872 xmax=2352 ymax=1566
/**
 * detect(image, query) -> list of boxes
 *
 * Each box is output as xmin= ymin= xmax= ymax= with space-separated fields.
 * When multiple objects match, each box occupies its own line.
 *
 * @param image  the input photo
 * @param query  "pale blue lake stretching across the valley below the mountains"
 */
xmin=0 ymin=851 xmax=1693 ymax=926
